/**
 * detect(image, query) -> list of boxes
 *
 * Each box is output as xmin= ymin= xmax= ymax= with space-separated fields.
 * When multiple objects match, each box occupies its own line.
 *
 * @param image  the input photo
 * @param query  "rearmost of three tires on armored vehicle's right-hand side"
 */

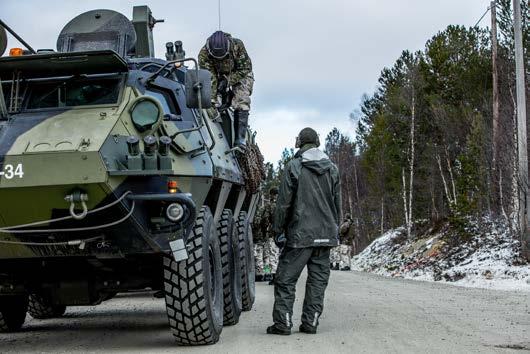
xmin=236 ymin=211 xmax=256 ymax=311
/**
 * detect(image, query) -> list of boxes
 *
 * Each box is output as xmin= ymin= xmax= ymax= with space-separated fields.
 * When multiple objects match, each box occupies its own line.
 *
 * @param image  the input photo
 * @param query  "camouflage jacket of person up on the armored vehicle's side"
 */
xmin=199 ymin=34 xmax=252 ymax=99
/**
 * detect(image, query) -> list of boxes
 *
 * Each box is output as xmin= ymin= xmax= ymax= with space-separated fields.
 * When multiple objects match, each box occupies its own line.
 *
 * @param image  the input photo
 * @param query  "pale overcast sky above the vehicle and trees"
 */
xmin=0 ymin=0 xmax=489 ymax=162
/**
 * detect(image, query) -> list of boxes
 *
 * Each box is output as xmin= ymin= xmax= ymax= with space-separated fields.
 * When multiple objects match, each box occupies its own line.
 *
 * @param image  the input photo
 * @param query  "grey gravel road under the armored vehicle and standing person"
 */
xmin=0 ymin=272 xmax=530 ymax=354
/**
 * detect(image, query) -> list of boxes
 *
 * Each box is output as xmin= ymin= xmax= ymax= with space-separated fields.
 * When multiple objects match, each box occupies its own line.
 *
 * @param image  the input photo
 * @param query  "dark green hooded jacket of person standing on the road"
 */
xmin=273 ymin=144 xmax=341 ymax=248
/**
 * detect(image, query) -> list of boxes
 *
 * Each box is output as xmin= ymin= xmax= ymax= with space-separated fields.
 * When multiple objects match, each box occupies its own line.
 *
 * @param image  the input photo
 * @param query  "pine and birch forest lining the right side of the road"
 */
xmin=263 ymin=0 xmax=530 ymax=253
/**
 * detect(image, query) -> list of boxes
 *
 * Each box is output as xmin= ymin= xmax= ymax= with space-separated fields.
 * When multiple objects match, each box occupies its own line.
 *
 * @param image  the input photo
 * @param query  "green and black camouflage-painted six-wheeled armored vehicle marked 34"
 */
xmin=0 ymin=6 xmax=259 ymax=345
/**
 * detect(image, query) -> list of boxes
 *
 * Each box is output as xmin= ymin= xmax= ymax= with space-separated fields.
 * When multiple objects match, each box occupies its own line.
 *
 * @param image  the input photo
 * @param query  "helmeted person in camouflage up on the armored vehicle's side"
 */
xmin=199 ymin=31 xmax=254 ymax=146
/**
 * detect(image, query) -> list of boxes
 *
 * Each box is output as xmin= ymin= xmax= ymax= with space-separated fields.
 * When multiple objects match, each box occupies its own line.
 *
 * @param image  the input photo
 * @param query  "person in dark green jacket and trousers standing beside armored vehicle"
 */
xmin=267 ymin=128 xmax=341 ymax=335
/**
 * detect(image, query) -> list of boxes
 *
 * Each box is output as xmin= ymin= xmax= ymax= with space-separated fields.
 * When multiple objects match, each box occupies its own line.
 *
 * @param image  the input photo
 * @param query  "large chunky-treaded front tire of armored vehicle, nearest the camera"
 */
xmin=164 ymin=206 xmax=223 ymax=345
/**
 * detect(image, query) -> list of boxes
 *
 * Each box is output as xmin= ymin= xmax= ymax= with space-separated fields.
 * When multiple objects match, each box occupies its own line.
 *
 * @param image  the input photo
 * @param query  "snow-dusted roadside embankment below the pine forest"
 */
xmin=352 ymin=218 xmax=530 ymax=292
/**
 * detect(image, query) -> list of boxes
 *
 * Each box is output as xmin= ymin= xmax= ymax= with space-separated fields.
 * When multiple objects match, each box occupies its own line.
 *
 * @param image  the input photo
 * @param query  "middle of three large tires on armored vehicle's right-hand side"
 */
xmin=217 ymin=209 xmax=243 ymax=326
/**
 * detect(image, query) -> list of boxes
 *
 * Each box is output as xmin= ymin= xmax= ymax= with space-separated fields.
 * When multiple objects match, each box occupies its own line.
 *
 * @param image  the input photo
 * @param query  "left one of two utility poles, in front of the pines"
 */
xmin=490 ymin=0 xmax=502 ymax=210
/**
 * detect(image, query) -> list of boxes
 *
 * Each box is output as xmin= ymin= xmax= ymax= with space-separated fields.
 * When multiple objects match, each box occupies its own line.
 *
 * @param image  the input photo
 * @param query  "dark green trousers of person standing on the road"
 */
xmin=272 ymin=247 xmax=330 ymax=328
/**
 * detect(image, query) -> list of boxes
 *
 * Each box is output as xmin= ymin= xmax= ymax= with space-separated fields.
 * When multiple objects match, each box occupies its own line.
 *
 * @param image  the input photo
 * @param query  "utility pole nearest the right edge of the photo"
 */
xmin=513 ymin=0 xmax=530 ymax=259
